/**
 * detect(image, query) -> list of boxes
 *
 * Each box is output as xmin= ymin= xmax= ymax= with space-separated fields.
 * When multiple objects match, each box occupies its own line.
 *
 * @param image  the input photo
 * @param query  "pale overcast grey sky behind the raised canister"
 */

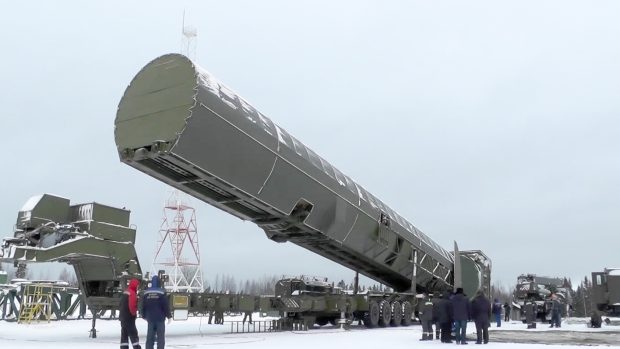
xmin=0 ymin=0 xmax=620 ymax=285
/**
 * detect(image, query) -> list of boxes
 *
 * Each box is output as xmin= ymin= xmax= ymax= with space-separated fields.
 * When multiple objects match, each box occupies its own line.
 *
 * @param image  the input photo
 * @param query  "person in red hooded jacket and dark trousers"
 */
xmin=118 ymin=279 xmax=142 ymax=349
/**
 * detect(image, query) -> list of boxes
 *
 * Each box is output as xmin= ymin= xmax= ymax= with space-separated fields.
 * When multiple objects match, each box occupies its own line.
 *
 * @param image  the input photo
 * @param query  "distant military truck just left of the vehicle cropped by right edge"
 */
xmin=512 ymin=274 xmax=571 ymax=323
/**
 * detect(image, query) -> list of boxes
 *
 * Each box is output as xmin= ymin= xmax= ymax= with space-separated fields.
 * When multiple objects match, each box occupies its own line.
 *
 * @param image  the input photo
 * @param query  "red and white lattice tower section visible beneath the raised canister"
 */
xmin=151 ymin=190 xmax=204 ymax=292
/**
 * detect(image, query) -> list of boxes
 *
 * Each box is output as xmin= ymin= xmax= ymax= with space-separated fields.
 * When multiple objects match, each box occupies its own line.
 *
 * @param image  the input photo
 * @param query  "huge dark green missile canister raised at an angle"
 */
xmin=114 ymin=54 xmax=491 ymax=321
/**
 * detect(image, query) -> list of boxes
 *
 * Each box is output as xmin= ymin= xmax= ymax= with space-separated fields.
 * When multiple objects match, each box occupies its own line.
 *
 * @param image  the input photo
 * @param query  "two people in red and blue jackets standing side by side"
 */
xmin=119 ymin=275 xmax=172 ymax=349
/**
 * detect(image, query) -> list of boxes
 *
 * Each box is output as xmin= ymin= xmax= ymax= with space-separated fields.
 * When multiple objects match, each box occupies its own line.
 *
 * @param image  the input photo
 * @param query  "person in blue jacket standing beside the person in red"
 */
xmin=142 ymin=275 xmax=172 ymax=349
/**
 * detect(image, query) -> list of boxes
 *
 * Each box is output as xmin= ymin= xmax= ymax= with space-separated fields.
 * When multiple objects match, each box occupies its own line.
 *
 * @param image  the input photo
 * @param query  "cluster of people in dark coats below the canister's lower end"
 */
xmin=418 ymin=288 xmax=492 ymax=344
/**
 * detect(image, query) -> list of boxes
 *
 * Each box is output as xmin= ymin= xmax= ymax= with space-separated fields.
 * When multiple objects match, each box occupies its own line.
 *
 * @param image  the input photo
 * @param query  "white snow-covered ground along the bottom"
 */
xmin=0 ymin=314 xmax=620 ymax=349
